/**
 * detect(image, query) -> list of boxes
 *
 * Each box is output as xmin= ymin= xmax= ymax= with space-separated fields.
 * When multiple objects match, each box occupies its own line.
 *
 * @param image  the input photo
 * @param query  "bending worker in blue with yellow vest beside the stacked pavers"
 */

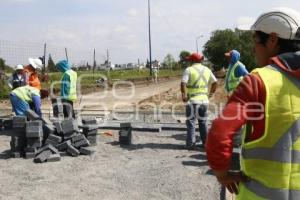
xmin=10 ymin=85 xmax=45 ymax=117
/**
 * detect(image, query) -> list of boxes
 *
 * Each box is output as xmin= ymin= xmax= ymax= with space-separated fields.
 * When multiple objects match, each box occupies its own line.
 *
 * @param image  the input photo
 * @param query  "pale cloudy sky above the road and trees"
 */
xmin=0 ymin=0 xmax=300 ymax=64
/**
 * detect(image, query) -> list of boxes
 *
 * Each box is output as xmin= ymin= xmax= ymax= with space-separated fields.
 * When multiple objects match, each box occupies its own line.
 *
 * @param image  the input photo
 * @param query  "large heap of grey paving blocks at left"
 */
xmin=5 ymin=110 xmax=98 ymax=163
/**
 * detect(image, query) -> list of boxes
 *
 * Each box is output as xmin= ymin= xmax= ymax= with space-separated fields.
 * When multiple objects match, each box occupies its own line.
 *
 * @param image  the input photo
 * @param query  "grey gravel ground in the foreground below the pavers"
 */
xmin=0 ymin=132 xmax=220 ymax=200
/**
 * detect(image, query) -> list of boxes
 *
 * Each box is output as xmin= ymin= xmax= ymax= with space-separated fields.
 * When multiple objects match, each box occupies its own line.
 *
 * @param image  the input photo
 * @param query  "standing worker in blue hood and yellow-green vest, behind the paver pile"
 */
xmin=56 ymin=60 xmax=77 ymax=118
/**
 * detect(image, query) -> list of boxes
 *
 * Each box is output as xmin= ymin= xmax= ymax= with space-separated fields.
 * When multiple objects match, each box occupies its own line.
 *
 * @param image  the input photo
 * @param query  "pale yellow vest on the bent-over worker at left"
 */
xmin=11 ymin=85 xmax=41 ymax=102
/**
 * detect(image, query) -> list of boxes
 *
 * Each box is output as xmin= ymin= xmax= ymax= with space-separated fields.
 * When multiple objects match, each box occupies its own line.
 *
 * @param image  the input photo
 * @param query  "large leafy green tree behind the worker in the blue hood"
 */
xmin=203 ymin=29 xmax=256 ymax=71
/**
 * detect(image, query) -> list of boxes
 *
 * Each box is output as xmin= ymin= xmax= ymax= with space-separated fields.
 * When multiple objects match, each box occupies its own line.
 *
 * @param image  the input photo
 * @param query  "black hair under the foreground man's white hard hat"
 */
xmin=255 ymin=31 xmax=300 ymax=54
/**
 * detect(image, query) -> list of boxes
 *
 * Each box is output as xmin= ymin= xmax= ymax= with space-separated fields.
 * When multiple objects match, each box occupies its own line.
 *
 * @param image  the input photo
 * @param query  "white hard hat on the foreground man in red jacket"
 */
xmin=251 ymin=7 xmax=300 ymax=40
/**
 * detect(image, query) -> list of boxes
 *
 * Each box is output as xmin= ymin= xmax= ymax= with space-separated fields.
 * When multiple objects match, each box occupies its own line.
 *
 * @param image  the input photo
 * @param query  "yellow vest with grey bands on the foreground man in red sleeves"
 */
xmin=237 ymin=65 xmax=300 ymax=200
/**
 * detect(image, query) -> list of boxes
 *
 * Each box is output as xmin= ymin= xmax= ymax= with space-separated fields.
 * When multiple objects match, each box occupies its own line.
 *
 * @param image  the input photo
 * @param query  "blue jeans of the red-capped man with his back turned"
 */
xmin=186 ymin=104 xmax=208 ymax=146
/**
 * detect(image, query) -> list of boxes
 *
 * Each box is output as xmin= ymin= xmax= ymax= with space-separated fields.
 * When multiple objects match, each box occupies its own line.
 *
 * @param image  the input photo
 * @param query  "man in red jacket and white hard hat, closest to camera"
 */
xmin=206 ymin=8 xmax=300 ymax=200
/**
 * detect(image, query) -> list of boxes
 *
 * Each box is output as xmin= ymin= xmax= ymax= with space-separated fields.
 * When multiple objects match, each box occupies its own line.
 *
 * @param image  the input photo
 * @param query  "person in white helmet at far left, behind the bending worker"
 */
xmin=8 ymin=65 xmax=26 ymax=89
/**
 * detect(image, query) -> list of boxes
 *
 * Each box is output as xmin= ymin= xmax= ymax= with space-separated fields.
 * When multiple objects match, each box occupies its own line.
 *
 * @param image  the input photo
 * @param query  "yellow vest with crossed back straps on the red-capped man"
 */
xmin=186 ymin=64 xmax=211 ymax=102
